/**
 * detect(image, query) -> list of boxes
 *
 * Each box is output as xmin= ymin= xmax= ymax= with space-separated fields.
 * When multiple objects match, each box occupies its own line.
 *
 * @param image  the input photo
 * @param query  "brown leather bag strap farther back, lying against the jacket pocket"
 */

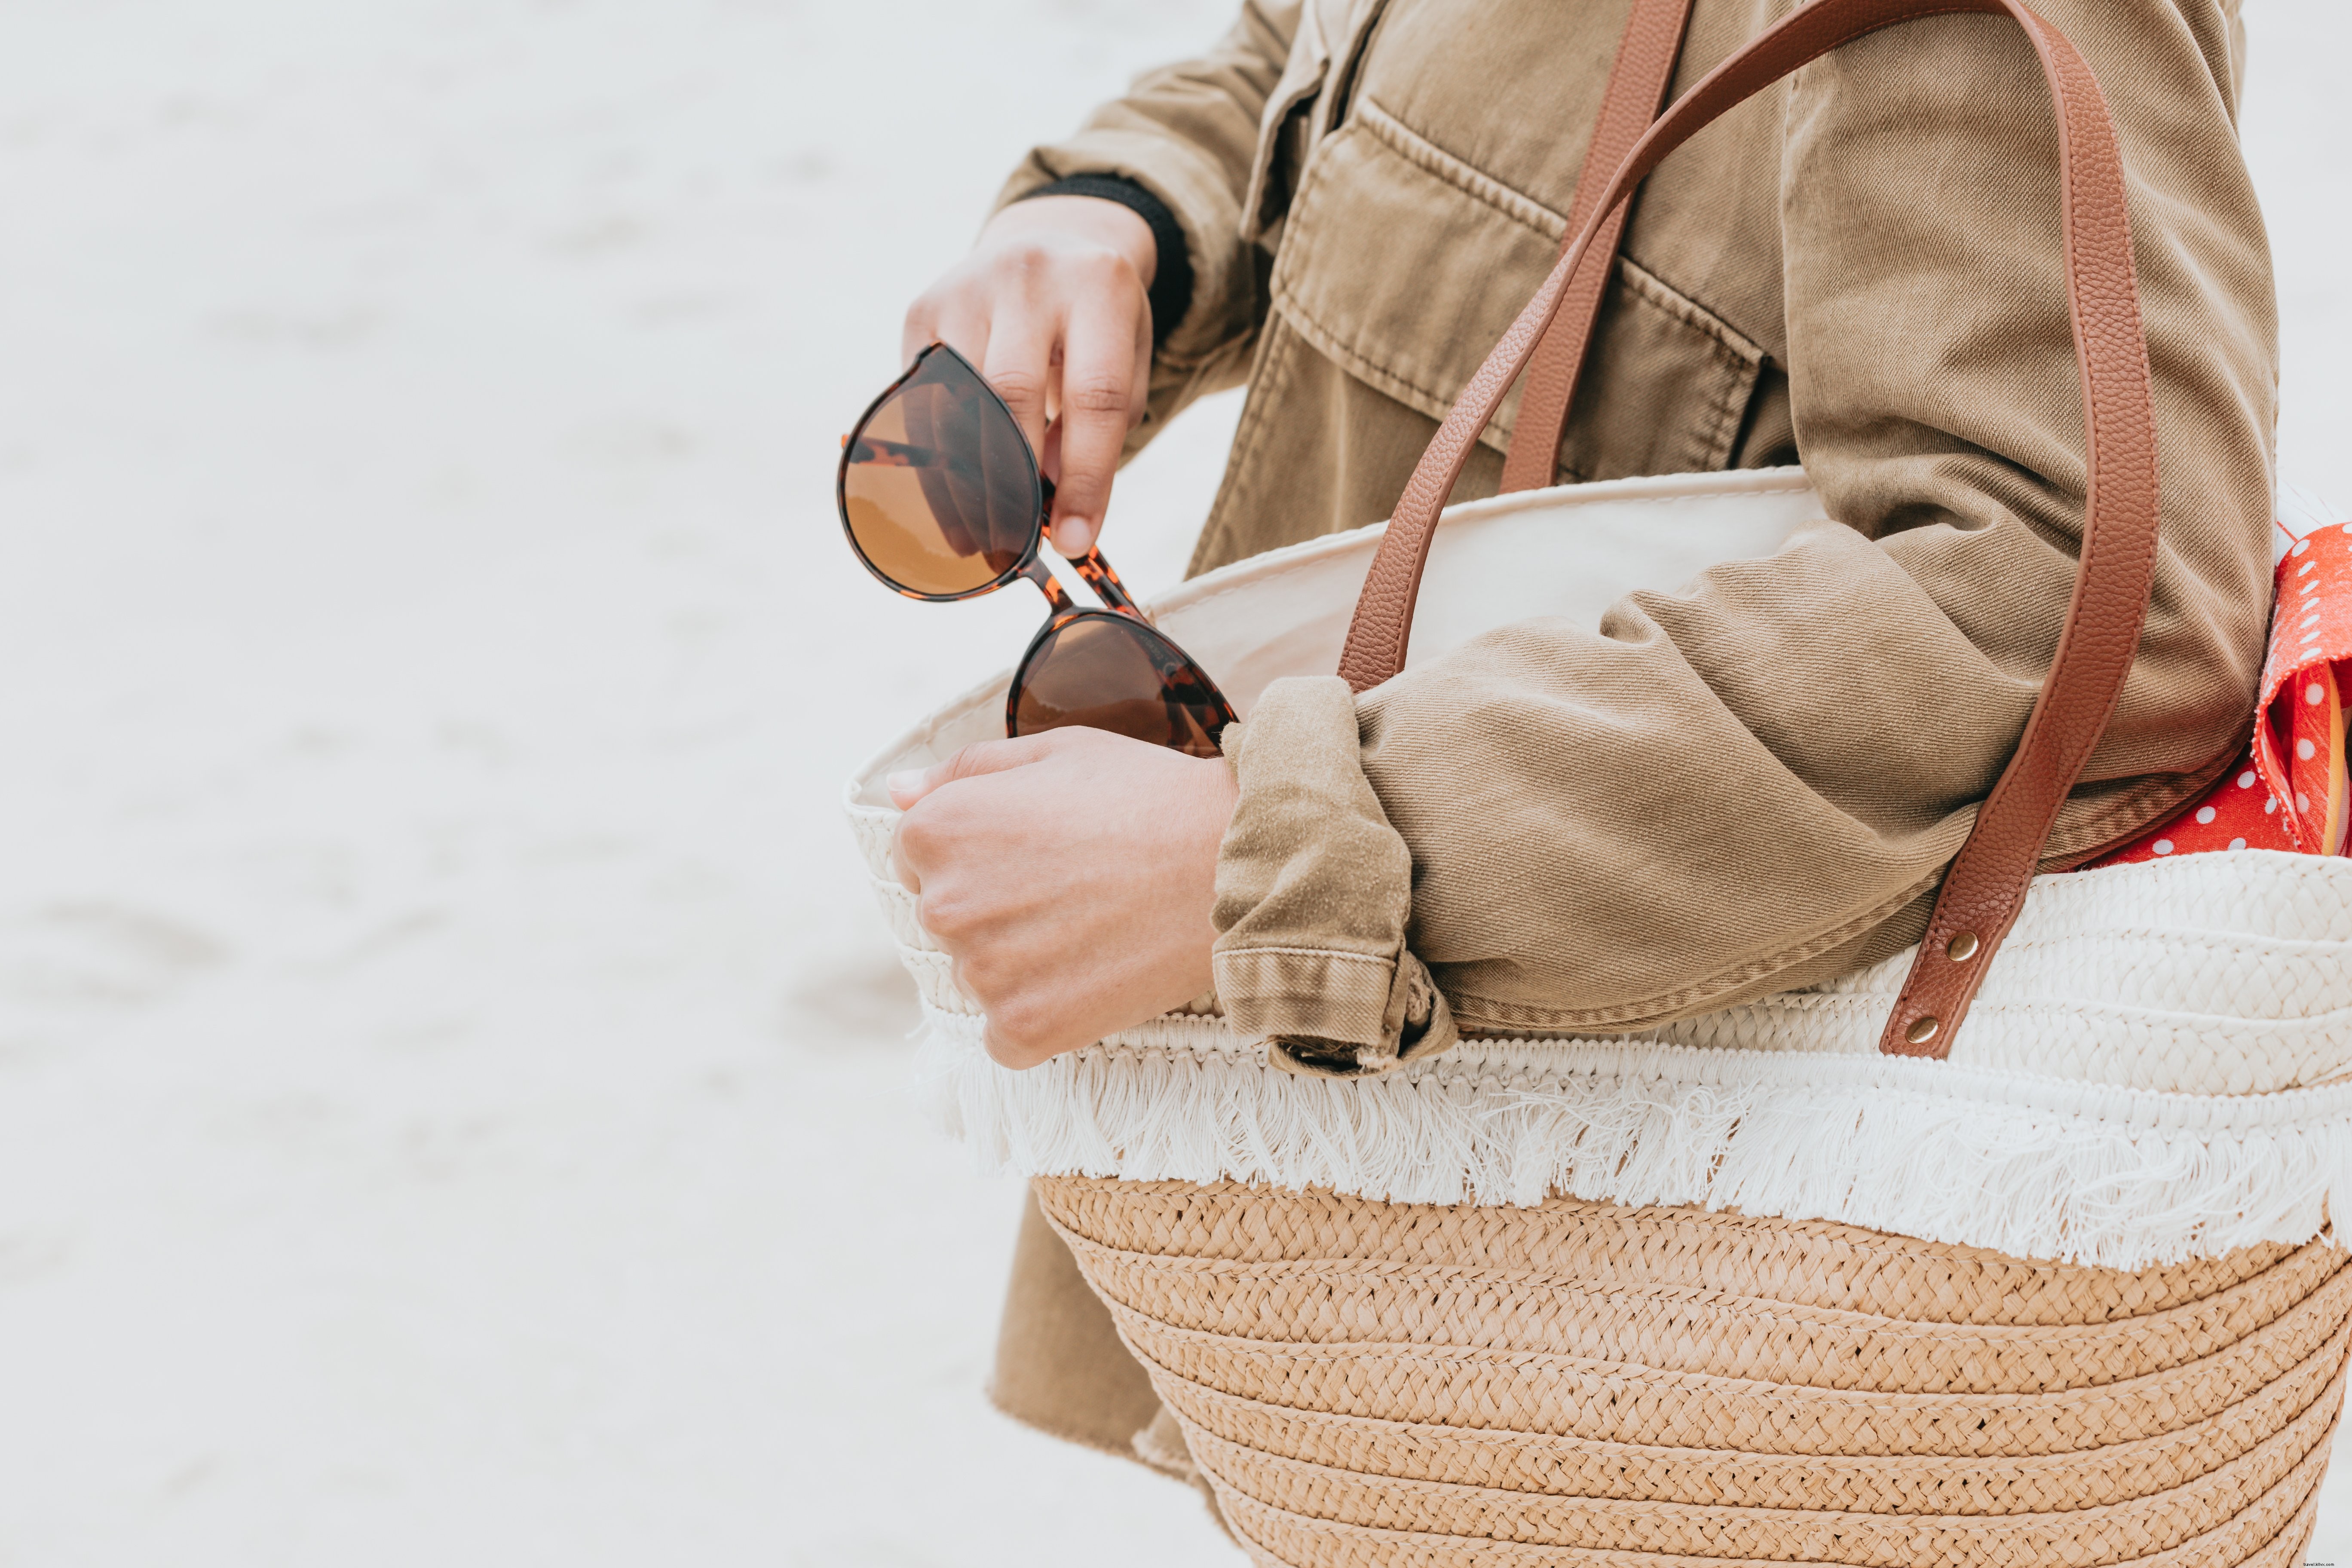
xmin=1503 ymin=0 xmax=1691 ymax=491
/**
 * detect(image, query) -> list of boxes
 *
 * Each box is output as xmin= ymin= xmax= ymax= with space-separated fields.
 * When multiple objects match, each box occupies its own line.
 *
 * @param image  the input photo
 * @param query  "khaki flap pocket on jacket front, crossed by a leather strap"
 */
xmin=1272 ymin=96 xmax=1764 ymax=480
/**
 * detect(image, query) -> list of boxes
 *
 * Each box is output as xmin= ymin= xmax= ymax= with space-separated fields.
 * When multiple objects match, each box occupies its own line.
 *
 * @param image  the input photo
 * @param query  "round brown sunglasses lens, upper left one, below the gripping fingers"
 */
xmin=842 ymin=348 xmax=1040 ymax=595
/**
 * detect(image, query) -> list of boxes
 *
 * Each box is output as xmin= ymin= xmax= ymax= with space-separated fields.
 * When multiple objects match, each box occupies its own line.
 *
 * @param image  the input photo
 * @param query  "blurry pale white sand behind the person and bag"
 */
xmin=0 ymin=0 xmax=2352 ymax=1568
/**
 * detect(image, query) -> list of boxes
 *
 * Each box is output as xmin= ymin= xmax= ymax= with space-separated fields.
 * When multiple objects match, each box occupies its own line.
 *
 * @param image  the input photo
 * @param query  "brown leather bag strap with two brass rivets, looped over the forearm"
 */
xmin=1338 ymin=0 xmax=2157 ymax=1056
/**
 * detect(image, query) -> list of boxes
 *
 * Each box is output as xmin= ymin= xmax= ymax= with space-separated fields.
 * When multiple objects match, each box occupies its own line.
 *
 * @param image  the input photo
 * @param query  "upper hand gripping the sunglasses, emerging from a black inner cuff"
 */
xmin=901 ymin=195 xmax=1160 ymax=557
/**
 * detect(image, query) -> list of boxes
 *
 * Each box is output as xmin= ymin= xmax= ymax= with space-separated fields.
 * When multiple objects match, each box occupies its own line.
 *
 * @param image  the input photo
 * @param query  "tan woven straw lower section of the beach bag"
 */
xmin=1037 ymin=1178 xmax=2352 ymax=1568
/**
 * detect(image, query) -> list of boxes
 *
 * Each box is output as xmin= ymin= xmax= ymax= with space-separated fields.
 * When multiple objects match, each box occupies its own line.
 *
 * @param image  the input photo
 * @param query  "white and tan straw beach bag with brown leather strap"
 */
xmin=849 ymin=0 xmax=2352 ymax=1568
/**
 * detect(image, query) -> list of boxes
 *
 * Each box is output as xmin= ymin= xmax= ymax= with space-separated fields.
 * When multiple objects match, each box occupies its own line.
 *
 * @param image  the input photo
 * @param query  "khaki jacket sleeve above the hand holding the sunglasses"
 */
xmin=997 ymin=0 xmax=1301 ymax=435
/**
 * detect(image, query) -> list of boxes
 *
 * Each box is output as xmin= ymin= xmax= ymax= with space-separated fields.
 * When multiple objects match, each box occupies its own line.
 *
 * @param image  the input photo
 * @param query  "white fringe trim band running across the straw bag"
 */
xmin=922 ymin=1011 xmax=2352 ymax=1269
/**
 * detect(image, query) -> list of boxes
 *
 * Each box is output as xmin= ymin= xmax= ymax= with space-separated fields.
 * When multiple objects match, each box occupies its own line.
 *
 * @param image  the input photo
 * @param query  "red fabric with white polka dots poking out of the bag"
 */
xmin=2091 ymin=503 xmax=2352 ymax=865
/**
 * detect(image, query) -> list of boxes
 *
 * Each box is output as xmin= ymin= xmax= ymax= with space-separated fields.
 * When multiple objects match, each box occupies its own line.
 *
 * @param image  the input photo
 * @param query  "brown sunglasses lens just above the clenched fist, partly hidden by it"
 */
xmin=1011 ymin=611 xmax=1232 ymax=757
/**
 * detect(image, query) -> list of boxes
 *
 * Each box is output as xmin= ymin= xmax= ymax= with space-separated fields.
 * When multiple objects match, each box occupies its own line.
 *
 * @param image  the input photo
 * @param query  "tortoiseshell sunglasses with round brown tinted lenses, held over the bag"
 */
xmin=837 ymin=343 xmax=1232 ymax=757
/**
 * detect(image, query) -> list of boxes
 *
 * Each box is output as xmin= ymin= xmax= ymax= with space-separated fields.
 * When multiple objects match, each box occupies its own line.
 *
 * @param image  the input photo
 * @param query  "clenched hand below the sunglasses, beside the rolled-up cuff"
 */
xmin=889 ymin=729 xmax=1237 ymax=1067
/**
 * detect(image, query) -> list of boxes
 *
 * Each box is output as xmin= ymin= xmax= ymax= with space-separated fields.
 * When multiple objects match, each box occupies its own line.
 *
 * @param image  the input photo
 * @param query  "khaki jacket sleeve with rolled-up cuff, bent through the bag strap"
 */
xmin=1216 ymin=0 xmax=2277 ymax=1070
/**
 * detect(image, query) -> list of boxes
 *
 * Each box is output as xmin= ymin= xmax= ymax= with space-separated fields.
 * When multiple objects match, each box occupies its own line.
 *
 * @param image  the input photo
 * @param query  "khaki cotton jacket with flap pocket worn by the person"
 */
xmin=1000 ymin=0 xmax=2277 ymax=1476
